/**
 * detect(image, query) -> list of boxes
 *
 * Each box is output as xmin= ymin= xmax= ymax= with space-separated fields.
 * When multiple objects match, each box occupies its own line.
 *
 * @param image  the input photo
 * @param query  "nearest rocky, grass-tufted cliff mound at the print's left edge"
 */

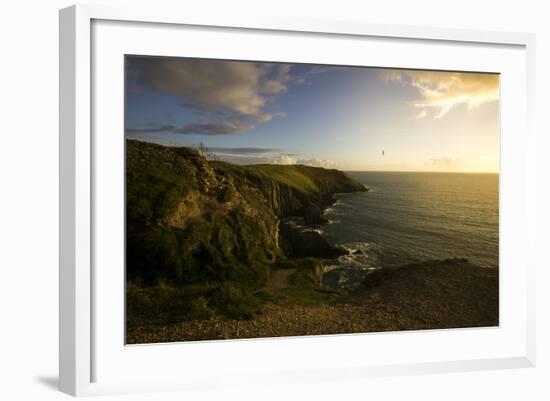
xmin=127 ymin=141 xmax=278 ymax=285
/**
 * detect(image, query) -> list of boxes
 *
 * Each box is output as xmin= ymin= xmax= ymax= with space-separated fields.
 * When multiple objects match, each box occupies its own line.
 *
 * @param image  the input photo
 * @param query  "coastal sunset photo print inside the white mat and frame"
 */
xmin=124 ymin=55 xmax=500 ymax=344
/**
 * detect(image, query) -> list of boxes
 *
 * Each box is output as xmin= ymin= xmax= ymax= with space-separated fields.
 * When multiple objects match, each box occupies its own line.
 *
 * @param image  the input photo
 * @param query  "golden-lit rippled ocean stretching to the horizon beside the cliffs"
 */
xmin=322 ymin=172 xmax=499 ymax=287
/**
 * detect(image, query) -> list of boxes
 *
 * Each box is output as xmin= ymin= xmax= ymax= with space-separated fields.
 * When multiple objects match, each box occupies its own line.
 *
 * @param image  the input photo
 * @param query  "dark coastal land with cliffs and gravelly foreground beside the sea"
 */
xmin=126 ymin=140 xmax=498 ymax=344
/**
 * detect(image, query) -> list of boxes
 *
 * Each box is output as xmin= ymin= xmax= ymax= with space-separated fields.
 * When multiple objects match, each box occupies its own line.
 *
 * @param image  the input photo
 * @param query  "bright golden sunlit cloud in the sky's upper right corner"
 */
xmin=382 ymin=70 xmax=499 ymax=119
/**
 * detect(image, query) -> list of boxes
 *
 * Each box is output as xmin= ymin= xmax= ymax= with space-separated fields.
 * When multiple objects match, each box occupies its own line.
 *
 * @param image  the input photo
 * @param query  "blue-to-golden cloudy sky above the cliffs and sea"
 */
xmin=125 ymin=56 xmax=499 ymax=172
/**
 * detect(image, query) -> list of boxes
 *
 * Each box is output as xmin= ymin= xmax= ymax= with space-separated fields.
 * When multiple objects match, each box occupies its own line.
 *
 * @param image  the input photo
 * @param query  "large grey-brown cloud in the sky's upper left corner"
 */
xmin=128 ymin=57 xmax=291 ymax=122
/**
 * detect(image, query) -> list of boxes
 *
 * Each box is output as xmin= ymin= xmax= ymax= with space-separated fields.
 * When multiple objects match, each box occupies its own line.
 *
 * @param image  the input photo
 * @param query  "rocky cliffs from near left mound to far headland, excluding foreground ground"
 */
xmin=126 ymin=140 xmax=365 ymax=286
